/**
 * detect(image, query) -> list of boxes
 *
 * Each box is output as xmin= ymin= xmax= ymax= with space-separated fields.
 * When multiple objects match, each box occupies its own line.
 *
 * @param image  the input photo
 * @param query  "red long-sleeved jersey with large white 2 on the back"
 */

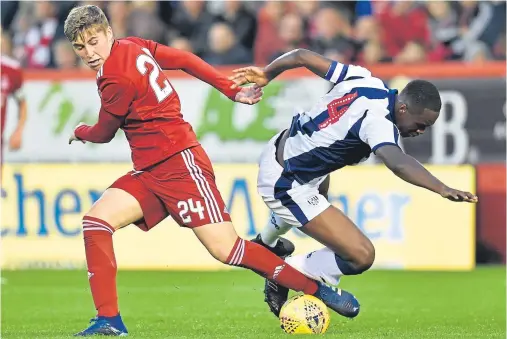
xmin=74 ymin=37 xmax=239 ymax=170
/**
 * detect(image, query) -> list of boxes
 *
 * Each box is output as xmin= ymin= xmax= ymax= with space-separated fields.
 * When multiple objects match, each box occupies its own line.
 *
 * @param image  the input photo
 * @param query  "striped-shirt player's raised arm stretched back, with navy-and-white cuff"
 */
xmin=229 ymin=48 xmax=346 ymax=88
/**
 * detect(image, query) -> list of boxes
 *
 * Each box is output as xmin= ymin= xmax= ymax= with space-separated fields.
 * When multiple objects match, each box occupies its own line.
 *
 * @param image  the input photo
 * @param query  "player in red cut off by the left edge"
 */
xmin=0 ymin=30 xmax=26 ymax=179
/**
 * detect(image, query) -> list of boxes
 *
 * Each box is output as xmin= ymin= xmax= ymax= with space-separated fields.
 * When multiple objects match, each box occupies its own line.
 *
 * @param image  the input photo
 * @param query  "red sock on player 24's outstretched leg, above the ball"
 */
xmin=227 ymin=237 xmax=318 ymax=294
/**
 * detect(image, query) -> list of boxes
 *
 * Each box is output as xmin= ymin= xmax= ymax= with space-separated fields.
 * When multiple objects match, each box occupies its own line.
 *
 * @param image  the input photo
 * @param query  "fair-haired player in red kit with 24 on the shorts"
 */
xmin=64 ymin=6 xmax=355 ymax=336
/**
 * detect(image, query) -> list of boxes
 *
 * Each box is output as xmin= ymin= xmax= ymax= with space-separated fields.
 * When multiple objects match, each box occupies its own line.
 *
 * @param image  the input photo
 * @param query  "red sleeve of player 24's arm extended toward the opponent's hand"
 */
xmin=152 ymin=44 xmax=240 ymax=101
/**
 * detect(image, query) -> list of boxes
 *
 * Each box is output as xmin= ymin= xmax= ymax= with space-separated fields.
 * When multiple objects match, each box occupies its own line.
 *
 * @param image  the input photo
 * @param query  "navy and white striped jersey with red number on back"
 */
xmin=280 ymin=62 xmax=399 ymax=189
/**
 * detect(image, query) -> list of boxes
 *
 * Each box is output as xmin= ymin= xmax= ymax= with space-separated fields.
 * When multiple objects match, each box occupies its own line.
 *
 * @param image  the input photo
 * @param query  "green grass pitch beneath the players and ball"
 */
xmin=1 ymin=267 xmax=506 ymax=339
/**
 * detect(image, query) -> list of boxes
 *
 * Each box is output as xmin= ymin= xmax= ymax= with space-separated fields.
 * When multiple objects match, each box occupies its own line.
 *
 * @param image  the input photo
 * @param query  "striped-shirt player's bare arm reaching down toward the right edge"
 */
xmin=375 ymin=145 xmax=478 ymax=202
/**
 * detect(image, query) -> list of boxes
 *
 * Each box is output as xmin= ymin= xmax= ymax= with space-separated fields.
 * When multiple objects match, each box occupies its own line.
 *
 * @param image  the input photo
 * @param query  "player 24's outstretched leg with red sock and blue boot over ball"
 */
xmin=193 ymin=222 xmax=359 ymax=318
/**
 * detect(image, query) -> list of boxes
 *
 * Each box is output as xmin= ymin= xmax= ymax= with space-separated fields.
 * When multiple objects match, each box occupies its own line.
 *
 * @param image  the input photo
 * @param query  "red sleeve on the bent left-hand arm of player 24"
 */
xmin=74 ymin=109 xmax=124 ymax=144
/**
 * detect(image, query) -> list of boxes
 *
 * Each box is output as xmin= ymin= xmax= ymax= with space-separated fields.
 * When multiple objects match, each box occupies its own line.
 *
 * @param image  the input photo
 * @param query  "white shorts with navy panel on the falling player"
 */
xmin=257 ymin=131 xmax=331 ymax=227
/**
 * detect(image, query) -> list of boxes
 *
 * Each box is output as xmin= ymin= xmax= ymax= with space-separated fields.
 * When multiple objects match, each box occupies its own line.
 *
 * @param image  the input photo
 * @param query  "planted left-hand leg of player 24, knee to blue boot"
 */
xmin=76 ymin=188 xmax=143 ymax=336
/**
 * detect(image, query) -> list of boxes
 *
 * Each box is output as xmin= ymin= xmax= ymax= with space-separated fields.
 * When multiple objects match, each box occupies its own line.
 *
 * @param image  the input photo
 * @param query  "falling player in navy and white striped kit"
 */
xmin=230 ymin=49 xmax=477 ymax=315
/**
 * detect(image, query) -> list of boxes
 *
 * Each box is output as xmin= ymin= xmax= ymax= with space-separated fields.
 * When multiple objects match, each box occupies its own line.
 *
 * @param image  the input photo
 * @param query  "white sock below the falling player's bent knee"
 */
xmin=285 ymin=247 xmax=343 ymax=286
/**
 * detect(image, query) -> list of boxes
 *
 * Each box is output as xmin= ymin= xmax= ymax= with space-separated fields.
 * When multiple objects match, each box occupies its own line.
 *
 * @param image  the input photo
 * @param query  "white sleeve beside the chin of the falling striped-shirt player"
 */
xmin=359 ymin=113 xmax=400 ymax=152
